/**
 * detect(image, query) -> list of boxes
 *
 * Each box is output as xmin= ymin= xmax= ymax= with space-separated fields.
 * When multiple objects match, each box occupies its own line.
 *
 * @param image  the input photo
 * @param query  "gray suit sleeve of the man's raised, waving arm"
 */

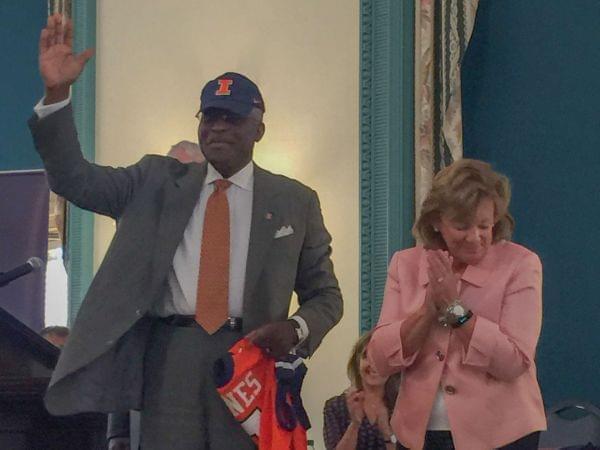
xmin=28 ymin=105 xmax=149 ymax=218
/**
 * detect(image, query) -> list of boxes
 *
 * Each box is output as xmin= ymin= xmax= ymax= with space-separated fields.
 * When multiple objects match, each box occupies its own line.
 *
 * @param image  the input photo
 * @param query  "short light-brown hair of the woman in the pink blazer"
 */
xmin=413 ymin=158 xmax=515 ymax=248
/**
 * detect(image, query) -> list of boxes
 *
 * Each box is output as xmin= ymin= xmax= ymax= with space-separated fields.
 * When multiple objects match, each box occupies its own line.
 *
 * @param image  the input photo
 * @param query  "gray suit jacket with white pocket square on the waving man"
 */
xmin=29 ymin=106 xmax=342 ymax=414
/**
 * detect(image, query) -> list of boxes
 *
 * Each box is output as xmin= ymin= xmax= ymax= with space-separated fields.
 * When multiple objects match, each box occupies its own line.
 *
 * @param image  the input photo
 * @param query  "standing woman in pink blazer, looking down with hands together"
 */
xmin=368 ymin=159 xmax=546 ymax=450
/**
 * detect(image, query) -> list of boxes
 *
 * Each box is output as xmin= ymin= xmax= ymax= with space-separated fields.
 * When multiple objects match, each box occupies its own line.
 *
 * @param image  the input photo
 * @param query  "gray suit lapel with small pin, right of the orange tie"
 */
xmin=244 ymin=165 xmax=280 ymax=312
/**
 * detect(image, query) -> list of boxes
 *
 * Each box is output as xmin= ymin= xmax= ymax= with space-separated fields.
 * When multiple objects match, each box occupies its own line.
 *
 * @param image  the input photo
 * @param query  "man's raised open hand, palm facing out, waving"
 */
xmin=39 ymin=14 xmax=94 ymax=103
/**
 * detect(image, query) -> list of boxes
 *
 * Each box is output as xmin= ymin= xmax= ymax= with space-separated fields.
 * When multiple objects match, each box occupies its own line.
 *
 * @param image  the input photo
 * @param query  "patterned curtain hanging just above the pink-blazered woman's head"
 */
xmin=415 ymin=0 xmax=479 ymax=214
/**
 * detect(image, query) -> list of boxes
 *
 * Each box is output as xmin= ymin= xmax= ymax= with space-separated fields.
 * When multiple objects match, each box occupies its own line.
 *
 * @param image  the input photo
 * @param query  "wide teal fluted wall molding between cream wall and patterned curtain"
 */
xmin=360 ymin=0 xmax=415 ymax=332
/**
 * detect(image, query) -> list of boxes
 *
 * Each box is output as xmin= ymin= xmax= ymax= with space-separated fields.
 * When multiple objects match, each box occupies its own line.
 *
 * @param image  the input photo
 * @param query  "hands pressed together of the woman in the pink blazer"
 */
xmin=427 ymin=250 xmax=458 ymax=310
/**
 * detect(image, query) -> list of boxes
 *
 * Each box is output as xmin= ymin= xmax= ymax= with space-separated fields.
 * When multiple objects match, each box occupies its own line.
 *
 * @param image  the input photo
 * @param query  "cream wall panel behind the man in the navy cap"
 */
xmin=95 ymin=0 xmax=359 ymax=448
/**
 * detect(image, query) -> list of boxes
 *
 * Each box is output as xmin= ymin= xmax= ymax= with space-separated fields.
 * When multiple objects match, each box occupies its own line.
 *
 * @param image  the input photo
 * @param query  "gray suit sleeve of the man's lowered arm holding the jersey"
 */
xmin=294 ymin=191 xmax=343 ymax=356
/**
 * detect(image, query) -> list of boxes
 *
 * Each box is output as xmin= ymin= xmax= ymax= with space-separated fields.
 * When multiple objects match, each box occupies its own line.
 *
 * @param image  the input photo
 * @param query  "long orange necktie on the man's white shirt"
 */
xmin=196 ymin=180 xmax=231 ymax=334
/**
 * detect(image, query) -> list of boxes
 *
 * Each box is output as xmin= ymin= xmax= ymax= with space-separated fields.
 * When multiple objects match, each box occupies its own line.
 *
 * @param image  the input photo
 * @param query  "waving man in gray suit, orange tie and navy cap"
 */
xmin=29 ymin=15 xmax=342 ymax=450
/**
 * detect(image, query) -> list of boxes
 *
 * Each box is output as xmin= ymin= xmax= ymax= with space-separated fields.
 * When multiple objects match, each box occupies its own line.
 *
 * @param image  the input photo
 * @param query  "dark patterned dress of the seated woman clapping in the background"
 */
xmin=323 ymin=394 xmax=401 ymax=450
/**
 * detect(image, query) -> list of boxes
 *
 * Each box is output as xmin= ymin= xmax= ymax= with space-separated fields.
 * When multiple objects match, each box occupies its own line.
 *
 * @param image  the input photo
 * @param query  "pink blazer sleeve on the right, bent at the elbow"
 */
xmin=463 ymin=253 xmax=542 ymax=381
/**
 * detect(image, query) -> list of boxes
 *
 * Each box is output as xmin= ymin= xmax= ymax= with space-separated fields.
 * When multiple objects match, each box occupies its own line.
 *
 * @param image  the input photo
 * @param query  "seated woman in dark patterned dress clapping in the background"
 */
xmin=323 ymin=332 xmax=400 ymax=450
